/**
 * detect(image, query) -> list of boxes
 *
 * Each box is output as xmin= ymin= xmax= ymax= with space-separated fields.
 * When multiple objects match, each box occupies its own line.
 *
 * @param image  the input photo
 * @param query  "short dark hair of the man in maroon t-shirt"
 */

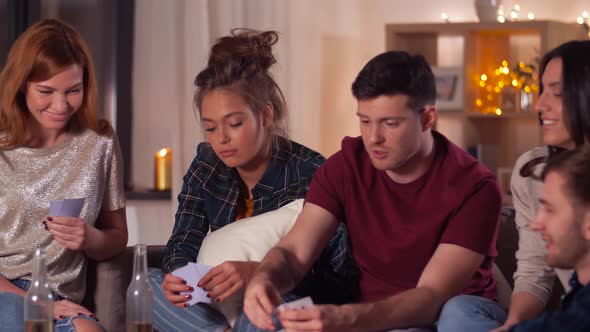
xmin=352 ymin=51 xmax=436 ymax=112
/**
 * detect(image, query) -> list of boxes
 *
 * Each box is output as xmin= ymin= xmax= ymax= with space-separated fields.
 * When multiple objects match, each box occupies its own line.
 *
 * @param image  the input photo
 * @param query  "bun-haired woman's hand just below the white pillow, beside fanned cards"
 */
xmin=197 ymin=262 xmax=260 ymax=302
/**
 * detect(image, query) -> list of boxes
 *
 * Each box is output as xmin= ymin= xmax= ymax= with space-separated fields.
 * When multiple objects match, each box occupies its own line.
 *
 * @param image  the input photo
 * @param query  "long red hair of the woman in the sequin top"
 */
xmin=0 ymin=19 xmax=111 ymax=149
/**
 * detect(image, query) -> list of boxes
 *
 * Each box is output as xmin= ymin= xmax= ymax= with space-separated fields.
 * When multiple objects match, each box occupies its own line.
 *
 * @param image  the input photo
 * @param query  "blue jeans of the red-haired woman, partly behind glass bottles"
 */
xmin=0 ymin=279 xmax=104 ymax=332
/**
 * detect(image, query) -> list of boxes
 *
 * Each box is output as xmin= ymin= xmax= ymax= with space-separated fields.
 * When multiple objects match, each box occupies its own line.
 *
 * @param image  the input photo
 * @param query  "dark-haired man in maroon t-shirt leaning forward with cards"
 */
xmin=244 ymin=52 xmax=501 ymax=331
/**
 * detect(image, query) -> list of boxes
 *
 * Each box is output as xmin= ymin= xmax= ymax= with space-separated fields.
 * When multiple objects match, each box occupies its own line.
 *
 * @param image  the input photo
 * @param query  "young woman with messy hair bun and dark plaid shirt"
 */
xmin=150 ymin=29 xmax=350 ymax=331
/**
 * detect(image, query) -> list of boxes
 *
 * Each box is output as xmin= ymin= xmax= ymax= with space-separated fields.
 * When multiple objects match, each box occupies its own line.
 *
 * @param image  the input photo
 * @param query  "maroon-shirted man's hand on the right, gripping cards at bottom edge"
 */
xmin=279 ymin=305 xmax=349 ymax=332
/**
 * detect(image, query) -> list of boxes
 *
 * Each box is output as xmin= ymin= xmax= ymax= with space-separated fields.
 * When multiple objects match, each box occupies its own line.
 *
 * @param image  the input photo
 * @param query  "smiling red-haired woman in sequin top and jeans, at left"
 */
xmin=0 ymin=19 xmax=127 ymax=332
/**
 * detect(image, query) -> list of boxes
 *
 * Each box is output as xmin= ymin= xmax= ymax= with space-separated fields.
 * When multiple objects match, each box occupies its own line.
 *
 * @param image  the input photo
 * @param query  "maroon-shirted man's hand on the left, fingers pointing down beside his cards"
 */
xmin=244 ymin=275 xmax=282 ymax=331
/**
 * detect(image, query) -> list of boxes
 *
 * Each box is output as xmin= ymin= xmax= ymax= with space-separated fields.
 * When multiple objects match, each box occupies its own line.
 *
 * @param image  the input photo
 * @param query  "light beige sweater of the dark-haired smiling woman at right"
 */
xmin=510 ymin=147 xmax=573 ymax=304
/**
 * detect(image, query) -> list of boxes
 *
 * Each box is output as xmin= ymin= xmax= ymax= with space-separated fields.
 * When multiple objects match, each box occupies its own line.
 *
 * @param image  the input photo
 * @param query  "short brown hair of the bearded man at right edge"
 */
xmin=543 ymin=145 xmax=590 ymax=207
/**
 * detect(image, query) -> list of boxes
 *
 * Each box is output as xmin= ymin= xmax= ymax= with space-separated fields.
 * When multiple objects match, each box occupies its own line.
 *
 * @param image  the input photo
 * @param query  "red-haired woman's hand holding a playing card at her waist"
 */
xmin=43 ymin=217 xmax=88 ymax=251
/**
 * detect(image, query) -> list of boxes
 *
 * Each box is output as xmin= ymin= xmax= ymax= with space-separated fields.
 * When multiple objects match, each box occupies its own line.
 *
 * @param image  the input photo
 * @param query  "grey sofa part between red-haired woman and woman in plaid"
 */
xmin=83 ymin=246 xmax=164 ymax=332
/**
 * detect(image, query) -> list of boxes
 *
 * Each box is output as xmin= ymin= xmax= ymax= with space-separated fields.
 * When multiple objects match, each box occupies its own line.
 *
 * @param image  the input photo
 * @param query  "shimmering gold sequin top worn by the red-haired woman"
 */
xmin=0 ymin=129 xmax=125 ymax=303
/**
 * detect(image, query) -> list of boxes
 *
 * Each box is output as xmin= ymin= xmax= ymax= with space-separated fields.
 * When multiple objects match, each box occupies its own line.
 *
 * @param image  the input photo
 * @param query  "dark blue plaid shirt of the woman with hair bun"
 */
xmin=162 ymin=140 xmax=356 ymax=300
